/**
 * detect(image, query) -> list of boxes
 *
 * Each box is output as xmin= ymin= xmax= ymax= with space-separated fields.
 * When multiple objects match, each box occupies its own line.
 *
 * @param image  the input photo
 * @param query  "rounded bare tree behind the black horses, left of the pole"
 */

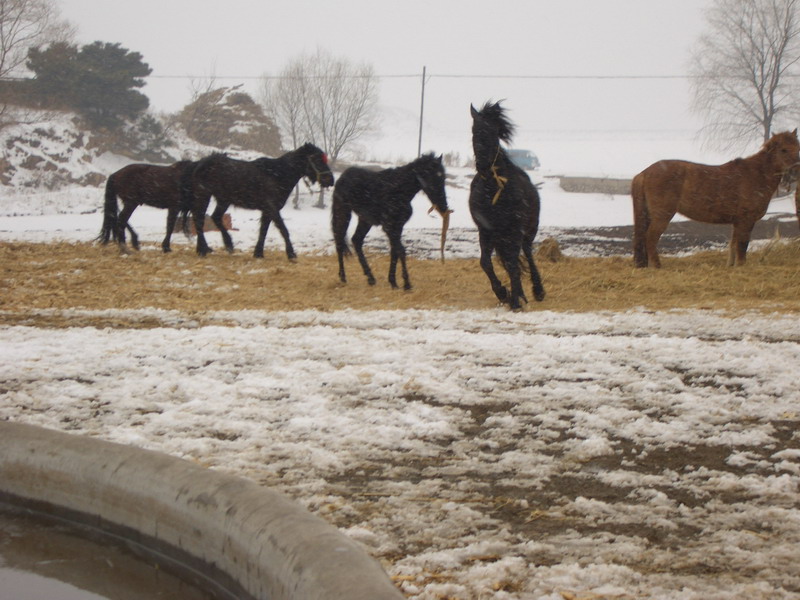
xmin=264 ymin=50 xmax=378 ymax=206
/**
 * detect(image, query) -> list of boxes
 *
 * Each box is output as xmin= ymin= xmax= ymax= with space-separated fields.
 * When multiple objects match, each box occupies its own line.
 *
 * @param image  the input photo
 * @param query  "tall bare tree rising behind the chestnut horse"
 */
xmin=691 ymin=0 xmax=800 ymax=148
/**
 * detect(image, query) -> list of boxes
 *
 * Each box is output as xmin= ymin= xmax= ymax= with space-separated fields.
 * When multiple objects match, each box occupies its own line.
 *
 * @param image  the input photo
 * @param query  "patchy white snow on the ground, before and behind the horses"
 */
xmin=0 ymin=157 xmax=800 ymax=600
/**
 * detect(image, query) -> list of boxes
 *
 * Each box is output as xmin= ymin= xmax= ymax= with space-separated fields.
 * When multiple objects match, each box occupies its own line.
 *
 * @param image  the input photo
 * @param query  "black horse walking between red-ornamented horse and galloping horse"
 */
xmin=331 ymin=154 xmax=450 ymax=290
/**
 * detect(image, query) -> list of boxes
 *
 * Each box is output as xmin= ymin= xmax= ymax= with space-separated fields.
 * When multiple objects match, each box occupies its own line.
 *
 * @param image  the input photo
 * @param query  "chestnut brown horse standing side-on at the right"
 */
xmin=631 ymin=129 xmax=800 ymax=268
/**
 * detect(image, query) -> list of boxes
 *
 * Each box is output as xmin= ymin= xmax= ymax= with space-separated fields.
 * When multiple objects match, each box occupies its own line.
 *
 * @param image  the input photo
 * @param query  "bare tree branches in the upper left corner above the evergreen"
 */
xmin=0 ymin=0 xmax=75 ymax=129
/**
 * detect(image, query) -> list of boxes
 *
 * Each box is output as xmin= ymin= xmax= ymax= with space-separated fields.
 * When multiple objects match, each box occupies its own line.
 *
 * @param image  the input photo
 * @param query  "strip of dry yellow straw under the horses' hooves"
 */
xmin=0 ymin=240 xmax=800 ymax=326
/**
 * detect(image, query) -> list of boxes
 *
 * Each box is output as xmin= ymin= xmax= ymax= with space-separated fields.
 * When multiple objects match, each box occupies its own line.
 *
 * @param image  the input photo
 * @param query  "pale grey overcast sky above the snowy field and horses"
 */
xmin=59 ymin=0 xmax=709 ymax=159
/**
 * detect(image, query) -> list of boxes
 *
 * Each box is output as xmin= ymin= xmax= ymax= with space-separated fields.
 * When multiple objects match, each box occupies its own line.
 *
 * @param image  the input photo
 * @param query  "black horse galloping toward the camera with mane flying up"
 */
xmin=469 ymin=102 xmax=544 ymax=310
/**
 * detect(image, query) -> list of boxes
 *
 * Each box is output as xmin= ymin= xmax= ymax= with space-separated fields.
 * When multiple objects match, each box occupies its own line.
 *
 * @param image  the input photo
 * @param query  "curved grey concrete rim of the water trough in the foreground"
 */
xmin=0 ymin=422 xmax=403 ymax=600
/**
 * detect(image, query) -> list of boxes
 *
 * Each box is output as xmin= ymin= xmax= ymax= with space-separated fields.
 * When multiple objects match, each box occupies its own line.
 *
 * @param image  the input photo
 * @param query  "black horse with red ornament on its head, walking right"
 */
xmin=184 ymin=144 xmax=333 ymax=258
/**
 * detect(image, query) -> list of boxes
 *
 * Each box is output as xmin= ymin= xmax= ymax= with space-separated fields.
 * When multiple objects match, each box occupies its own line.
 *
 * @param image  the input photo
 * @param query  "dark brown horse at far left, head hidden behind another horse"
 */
xmin=97 ymin=160 xmax=197 ymax=253
